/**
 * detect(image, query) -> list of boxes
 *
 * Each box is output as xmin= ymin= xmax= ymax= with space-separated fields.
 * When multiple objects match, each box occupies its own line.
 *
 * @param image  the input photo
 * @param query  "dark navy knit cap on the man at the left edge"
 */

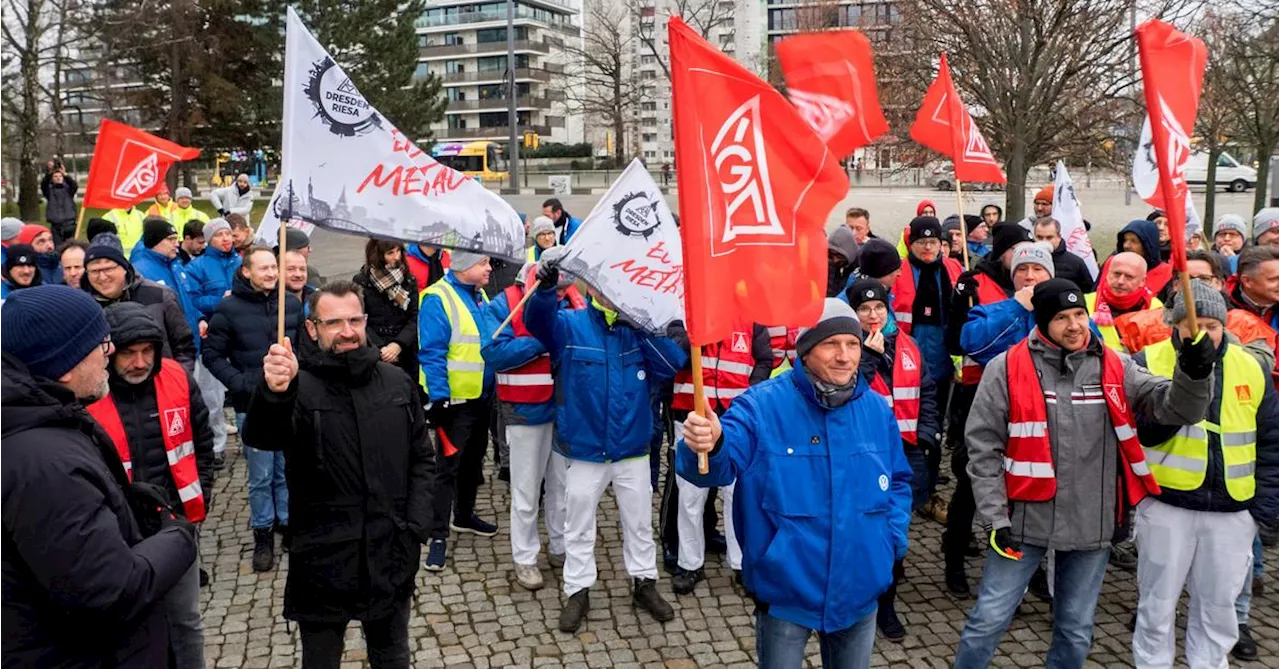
xmin=0 ymin=285 xmax=110 ymax=381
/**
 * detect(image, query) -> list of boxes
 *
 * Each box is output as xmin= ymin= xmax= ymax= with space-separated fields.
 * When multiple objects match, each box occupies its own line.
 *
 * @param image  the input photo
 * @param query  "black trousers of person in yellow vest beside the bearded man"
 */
xmin=431 ymin=398 xmax=493 ymax=539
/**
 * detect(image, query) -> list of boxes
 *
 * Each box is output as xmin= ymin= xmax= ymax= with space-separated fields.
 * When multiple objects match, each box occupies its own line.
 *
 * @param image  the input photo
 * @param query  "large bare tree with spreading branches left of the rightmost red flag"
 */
xmin=901 ymin=0 xmax=1199 ymax=219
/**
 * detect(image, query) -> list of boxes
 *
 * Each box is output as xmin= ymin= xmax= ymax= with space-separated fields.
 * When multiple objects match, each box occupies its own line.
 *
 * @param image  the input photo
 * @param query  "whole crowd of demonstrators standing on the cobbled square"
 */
xmin=0 ymin=179 xmax=1280 ymax=669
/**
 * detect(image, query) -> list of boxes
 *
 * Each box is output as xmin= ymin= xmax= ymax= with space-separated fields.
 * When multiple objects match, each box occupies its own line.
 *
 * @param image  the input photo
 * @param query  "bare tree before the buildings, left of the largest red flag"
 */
xmin=564 ymin=3 xmax=650 ymax=165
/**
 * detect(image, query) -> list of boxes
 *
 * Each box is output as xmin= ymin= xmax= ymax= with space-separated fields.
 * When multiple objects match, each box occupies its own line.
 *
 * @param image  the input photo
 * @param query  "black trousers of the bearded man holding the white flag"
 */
xmin=298 ymin=597 xmax=412 ymax=669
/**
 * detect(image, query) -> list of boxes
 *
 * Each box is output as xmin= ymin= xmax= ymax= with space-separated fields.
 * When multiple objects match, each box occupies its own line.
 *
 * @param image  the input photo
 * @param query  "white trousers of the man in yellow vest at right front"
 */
xmin=1133 ymin=498 xmax=1257 ymax=669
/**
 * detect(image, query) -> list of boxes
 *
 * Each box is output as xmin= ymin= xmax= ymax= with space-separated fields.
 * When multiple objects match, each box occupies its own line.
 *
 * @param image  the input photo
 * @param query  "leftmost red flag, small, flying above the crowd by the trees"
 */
xmin=84 ymin=119 xmax=200 ymax=209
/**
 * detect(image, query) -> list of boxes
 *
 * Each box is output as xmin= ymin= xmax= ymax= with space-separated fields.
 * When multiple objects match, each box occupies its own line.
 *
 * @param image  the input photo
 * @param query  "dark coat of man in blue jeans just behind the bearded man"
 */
xmin=201 ymin=272 xmax=302 ymax=411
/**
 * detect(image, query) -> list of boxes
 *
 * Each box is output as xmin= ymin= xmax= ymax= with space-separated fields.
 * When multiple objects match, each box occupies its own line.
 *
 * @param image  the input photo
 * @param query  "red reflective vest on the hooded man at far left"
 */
xmin=88 ymin=358 xmax=205 ymax=523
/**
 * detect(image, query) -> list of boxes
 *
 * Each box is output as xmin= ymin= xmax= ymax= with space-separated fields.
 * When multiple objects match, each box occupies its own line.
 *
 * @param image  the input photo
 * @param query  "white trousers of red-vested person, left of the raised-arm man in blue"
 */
xmin=507 ymin=423 xmax=567 ymax=564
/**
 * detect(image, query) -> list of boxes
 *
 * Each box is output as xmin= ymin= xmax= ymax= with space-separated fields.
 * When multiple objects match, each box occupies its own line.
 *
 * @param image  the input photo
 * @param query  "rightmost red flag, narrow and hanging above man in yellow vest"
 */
xmin=1135 ymin=20 xmax=1207 ymax=271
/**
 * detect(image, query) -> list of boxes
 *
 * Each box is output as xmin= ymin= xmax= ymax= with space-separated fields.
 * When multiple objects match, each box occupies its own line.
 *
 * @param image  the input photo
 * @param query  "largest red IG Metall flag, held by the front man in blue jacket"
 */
xmin=667 ymin=17 xmax=849 ymax=344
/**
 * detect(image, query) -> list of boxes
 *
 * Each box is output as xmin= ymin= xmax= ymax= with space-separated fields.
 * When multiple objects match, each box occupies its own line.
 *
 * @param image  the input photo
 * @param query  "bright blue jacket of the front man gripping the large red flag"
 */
xmin=676 ymin=367 xmax=911 ymax=632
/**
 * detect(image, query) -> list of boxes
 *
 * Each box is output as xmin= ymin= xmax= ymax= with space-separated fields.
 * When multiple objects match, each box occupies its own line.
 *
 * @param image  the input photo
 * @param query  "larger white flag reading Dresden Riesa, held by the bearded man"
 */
xmin=259 ymin=8 xmax=525 ymax=261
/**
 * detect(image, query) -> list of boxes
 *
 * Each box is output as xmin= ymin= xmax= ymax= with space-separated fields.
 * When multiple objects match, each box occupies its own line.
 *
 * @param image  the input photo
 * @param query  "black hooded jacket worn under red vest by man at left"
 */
xmin=106 ymin=302 xmax=220 ymax=519
